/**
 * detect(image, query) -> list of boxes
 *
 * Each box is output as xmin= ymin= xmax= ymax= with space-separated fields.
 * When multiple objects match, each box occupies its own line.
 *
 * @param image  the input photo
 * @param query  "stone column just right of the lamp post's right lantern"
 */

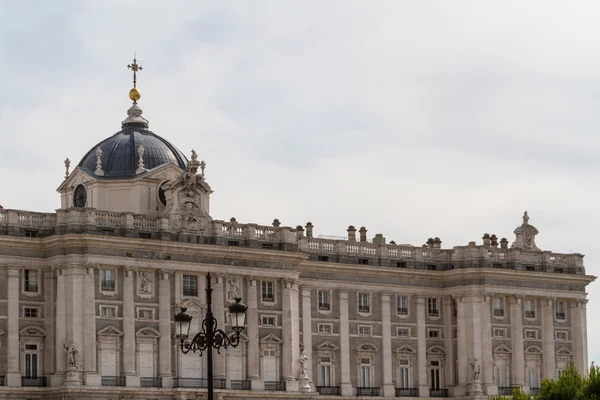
xmin=246 ymin=277 xmax=265 ymax=390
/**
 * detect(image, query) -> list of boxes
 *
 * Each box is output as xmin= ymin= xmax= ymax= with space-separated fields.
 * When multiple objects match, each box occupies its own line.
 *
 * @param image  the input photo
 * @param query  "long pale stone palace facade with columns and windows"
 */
xmin=0 ymin=101 xmax=595 ymax=400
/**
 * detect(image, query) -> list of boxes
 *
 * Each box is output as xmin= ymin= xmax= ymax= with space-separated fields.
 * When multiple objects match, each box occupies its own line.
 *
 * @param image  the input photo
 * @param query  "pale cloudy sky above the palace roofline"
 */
xmin=0 ymin=0 xmax=600 ymax=362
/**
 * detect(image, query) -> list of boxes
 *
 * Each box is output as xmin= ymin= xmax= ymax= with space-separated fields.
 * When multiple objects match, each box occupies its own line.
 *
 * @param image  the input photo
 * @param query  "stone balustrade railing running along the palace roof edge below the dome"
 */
xmin=0 ymin=209 xmax=583 ymax=269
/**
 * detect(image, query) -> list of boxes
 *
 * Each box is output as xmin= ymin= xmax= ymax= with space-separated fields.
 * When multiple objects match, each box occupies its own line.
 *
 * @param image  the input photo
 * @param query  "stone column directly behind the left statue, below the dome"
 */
xmin=61 ymin=265 xmax=86 ymax=386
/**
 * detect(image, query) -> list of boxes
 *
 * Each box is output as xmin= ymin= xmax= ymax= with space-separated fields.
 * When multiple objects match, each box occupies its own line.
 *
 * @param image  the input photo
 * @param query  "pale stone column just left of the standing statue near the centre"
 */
xmin=281 ymin=279 xmax=300 ymax=392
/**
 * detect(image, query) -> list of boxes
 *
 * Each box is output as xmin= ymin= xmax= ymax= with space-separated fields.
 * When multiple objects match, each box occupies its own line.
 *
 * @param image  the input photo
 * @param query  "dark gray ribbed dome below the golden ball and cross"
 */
xmin=79 ymin=105 xmax=187 ymax=179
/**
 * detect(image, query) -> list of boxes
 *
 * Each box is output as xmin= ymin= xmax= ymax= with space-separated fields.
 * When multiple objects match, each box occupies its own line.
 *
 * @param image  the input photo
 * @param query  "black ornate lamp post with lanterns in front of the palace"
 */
xmin=175 ymin=273 xmax=248 ymax=400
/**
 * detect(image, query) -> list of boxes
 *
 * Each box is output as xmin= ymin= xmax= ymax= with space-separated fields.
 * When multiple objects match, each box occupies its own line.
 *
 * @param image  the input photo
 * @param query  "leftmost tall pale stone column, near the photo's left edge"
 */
xmin=6 ymin=266 xmax=21 ymax=386
